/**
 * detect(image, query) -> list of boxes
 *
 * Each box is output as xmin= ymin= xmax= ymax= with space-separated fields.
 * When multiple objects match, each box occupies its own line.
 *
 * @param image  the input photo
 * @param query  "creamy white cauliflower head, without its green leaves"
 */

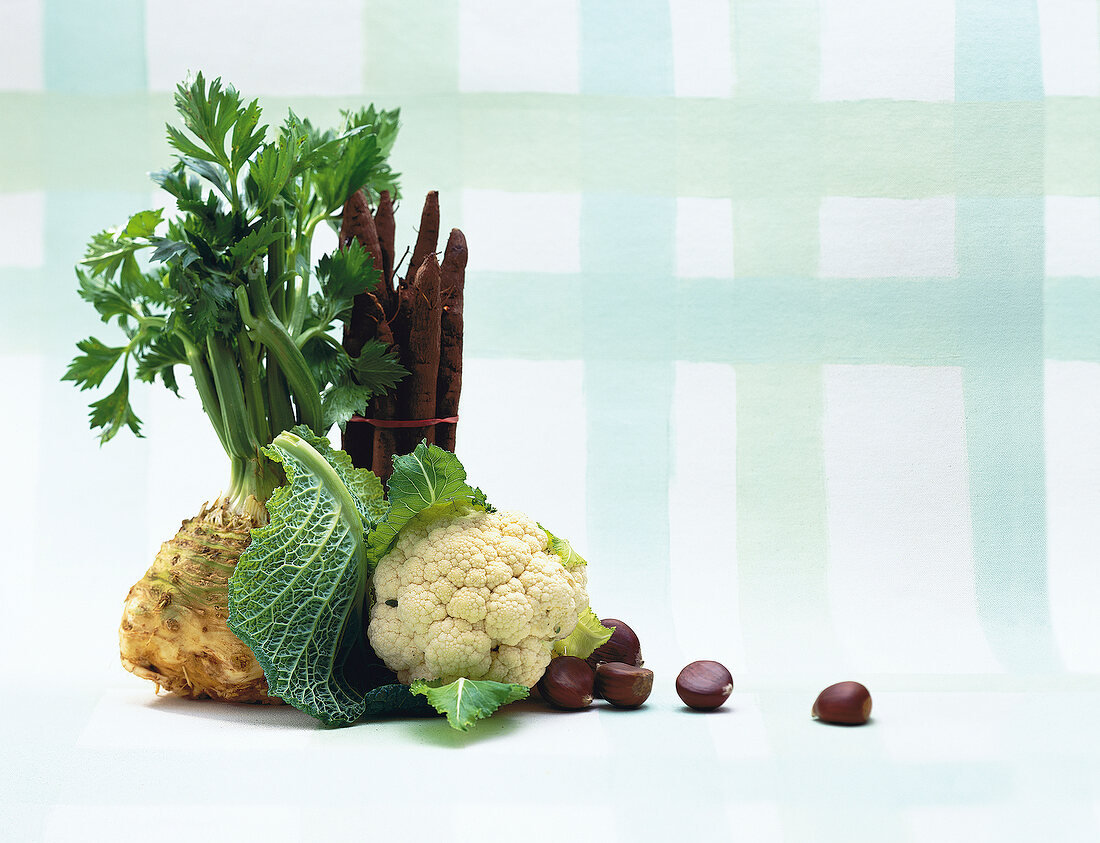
xmin=367 ymin=512 xmax=589 ymax=688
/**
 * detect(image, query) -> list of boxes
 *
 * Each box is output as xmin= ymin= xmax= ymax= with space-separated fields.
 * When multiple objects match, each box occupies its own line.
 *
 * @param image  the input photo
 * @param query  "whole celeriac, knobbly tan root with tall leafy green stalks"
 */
xmin=64 ymin=74 xmax=406 ymax=702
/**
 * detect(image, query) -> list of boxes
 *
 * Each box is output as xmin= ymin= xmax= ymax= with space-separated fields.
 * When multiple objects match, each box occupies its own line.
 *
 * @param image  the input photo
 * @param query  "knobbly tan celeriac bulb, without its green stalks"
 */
xmin=119 ymin=503 xmax=281 ymax=703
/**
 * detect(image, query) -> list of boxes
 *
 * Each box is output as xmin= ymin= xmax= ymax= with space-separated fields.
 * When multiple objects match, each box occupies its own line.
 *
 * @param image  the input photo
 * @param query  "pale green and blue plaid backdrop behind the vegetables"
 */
xmin=0 ymin=0 xmax=1100 ymax=836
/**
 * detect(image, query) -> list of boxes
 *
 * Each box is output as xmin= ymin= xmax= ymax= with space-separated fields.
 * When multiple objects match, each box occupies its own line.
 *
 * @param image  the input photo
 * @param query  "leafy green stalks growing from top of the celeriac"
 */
xmin=64 ymin=74 xmax=405 ymax=501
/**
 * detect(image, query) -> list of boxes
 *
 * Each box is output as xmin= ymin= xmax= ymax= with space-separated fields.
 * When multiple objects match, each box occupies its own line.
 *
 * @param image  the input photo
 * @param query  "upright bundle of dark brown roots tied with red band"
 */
xmin=340 ymin=190 xmax=466 ymax=480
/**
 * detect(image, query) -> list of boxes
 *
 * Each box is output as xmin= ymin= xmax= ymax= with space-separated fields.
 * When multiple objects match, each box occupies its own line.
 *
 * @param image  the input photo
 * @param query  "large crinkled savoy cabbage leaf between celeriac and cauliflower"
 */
xmin=228 ymin=427 xmax=381 ymax=724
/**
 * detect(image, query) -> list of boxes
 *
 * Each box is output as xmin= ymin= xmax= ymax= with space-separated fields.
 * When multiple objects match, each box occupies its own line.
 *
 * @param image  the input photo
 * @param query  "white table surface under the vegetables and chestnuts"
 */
xmin=0 ymin=658 xmax=1100 ymax=843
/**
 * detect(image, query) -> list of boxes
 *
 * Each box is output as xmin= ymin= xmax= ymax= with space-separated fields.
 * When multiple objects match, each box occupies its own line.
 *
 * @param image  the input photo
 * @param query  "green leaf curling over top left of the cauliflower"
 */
xmin=366 ymin=442 xmax=484 ymax=567
